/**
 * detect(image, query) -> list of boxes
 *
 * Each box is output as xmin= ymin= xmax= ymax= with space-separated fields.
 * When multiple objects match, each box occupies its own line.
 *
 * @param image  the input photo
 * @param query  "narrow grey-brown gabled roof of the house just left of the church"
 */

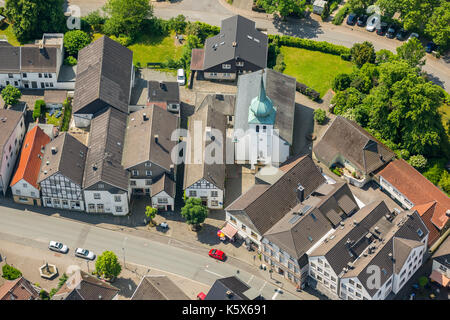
xmin=184 ymin=106 xmax=226 ymax=190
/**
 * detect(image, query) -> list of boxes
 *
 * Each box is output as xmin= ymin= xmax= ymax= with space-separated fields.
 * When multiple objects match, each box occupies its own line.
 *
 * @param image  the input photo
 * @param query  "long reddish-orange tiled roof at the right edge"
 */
xmin=378 ymin=159 xmax=450 ymax=230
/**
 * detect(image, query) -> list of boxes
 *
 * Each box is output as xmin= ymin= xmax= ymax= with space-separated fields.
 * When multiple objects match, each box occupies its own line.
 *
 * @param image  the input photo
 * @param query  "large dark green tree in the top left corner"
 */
xmin=5 ymin=0 xmax=66 ymax=42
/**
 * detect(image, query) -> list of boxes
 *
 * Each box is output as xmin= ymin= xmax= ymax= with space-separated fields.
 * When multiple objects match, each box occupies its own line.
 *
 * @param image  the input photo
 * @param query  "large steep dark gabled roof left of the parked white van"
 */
xmin=73 ymin=36 xmax=133 ymax=114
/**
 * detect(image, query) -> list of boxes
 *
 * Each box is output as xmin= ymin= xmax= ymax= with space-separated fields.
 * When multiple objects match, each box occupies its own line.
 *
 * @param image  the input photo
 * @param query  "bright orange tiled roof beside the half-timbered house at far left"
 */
xmin=11 ymin=126 xmax=50 ymax=189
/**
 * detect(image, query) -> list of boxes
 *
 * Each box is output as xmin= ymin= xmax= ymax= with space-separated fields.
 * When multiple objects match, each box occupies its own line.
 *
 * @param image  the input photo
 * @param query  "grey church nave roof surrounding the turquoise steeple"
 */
xmin=234 ymin=69 xmax=296 ymax=145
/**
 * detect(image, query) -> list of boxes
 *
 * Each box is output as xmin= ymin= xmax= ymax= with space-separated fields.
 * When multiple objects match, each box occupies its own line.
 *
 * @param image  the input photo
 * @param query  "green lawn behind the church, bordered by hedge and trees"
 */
xmin=281 ymin=46 xmax=353 ymax=97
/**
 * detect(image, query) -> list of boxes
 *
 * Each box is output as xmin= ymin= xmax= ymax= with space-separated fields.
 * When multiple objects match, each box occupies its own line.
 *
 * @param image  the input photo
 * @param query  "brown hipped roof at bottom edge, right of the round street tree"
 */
xmin=131 ymin=276 xmax=190 ymax=300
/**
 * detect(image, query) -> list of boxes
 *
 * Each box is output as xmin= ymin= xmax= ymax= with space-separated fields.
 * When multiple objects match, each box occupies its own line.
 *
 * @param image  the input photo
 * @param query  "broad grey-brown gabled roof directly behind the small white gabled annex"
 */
xmin=122 ymin=106 xmax=178 ymax=171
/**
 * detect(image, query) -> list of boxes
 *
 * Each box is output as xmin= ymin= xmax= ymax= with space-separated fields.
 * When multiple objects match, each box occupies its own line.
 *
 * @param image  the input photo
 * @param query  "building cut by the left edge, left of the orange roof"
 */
xmin=0 ymin=109 xmax=25 ymax=195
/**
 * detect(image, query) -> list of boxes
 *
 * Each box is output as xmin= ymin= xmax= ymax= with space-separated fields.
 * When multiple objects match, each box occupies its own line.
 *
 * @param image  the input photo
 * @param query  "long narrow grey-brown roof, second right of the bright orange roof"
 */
xmin=83 ymin=108 xmax=129 ymax=191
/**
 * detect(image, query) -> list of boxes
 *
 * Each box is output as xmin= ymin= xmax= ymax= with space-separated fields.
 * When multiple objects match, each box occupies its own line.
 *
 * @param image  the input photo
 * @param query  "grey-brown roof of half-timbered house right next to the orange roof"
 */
xmin=38 ymin=132 xmax=88 ymax=186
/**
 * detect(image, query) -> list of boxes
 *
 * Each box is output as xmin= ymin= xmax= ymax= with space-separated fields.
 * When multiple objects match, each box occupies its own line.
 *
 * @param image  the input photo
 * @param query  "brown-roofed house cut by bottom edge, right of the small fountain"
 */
xmin=52 ymin=270 xmax=119 ymax=300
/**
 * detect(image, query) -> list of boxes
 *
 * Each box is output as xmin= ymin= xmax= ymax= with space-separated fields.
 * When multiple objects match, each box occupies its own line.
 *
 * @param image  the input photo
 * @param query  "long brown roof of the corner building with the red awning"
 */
xmin=226 ymin=156 xmax=325 ymax=234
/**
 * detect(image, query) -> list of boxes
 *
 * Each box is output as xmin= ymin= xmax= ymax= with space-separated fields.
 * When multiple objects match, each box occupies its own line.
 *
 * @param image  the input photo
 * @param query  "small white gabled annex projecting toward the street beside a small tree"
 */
xmin=151 ymin=173 xmax=176 ymax=211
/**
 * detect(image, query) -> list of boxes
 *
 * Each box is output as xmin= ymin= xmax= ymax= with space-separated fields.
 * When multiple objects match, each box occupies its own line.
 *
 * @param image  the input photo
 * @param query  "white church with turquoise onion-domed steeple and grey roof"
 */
xmin=233 ymin=69 xmax=296 ymax=166
